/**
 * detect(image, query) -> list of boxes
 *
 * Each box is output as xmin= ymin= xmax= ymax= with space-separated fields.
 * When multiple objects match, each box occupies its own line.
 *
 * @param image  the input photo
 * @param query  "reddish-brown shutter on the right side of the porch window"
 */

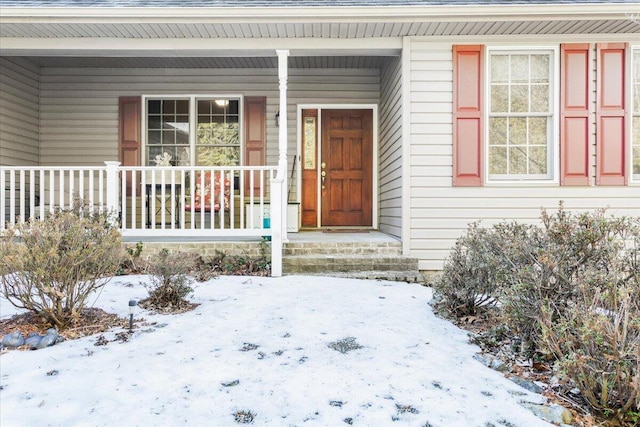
xmin=244 ymin=96 xmax=267 ymax=194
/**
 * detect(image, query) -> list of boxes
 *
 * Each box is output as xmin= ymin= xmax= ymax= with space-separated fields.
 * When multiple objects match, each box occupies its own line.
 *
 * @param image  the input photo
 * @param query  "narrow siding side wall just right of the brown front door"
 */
xmin=378 ymin=58 xmax=402 ymax=238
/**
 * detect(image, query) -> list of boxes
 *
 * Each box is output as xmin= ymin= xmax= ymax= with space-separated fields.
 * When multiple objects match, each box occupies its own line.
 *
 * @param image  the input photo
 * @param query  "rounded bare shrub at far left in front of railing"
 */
xmin=0 ymin=203 xmax=121 ymax=330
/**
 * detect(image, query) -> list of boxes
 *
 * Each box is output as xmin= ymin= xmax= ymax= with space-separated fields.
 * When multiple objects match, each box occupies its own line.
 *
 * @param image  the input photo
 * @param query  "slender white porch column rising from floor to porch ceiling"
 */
xmin=276 ymin=50 xmax=289 ymax=241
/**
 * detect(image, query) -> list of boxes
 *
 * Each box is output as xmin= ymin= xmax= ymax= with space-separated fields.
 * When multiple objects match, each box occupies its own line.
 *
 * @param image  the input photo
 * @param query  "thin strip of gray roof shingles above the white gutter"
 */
xmin=0 ymin=0 xmax=640 ymax=8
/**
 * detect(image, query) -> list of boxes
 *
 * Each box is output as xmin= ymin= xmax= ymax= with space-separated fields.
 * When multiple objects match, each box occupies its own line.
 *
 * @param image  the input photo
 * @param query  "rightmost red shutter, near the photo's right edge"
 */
xmin=596 ymin=43 xmax=629 ymax=185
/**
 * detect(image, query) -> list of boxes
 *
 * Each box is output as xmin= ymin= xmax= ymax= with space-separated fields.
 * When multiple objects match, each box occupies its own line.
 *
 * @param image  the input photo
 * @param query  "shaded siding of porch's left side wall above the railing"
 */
xmin=0 ymin=57 xmax=40 ymax=166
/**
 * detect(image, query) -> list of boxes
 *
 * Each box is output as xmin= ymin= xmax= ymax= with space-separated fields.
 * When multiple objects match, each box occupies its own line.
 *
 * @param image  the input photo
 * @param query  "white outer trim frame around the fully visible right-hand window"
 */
xmin=483 ymin=45 xmax=560 ymax=185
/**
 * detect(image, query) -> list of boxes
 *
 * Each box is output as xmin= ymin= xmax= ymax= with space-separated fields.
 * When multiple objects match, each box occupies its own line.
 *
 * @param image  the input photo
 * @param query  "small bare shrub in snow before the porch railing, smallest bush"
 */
xmin=140 ymin=249 xmax=194 ymax=310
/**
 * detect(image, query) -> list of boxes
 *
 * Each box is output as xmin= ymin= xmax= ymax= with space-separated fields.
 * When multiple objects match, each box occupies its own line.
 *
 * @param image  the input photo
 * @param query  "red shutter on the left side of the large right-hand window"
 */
xmin=453 ymin=45 xmax=484 ymax=187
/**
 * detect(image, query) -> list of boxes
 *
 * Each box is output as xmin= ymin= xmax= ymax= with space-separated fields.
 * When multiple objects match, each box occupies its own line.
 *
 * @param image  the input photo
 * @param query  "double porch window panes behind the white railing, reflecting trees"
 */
xmin=145 ymin=96 xmax=241 ymax=166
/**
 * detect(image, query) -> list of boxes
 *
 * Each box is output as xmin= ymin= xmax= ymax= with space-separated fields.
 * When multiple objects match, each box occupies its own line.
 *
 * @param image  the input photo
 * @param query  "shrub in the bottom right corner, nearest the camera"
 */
xmin=542 ymin=283 xmax=640 ymax=425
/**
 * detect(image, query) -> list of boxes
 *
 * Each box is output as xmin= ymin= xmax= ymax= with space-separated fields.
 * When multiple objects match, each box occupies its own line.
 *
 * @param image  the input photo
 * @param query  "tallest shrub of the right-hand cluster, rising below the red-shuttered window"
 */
xmin=500 ymin=205 xmax=638 ymax=353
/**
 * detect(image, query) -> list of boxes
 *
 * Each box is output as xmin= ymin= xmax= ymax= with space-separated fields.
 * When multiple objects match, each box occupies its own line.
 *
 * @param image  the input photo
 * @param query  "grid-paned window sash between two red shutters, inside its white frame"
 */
xmin=487 ymin=49 xmax=557 ymax=180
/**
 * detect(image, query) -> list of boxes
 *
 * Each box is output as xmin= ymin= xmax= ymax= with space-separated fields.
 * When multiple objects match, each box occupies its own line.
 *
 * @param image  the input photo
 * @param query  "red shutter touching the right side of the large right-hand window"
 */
xmin=560 ymin=43 xmax=593 ymax=185
